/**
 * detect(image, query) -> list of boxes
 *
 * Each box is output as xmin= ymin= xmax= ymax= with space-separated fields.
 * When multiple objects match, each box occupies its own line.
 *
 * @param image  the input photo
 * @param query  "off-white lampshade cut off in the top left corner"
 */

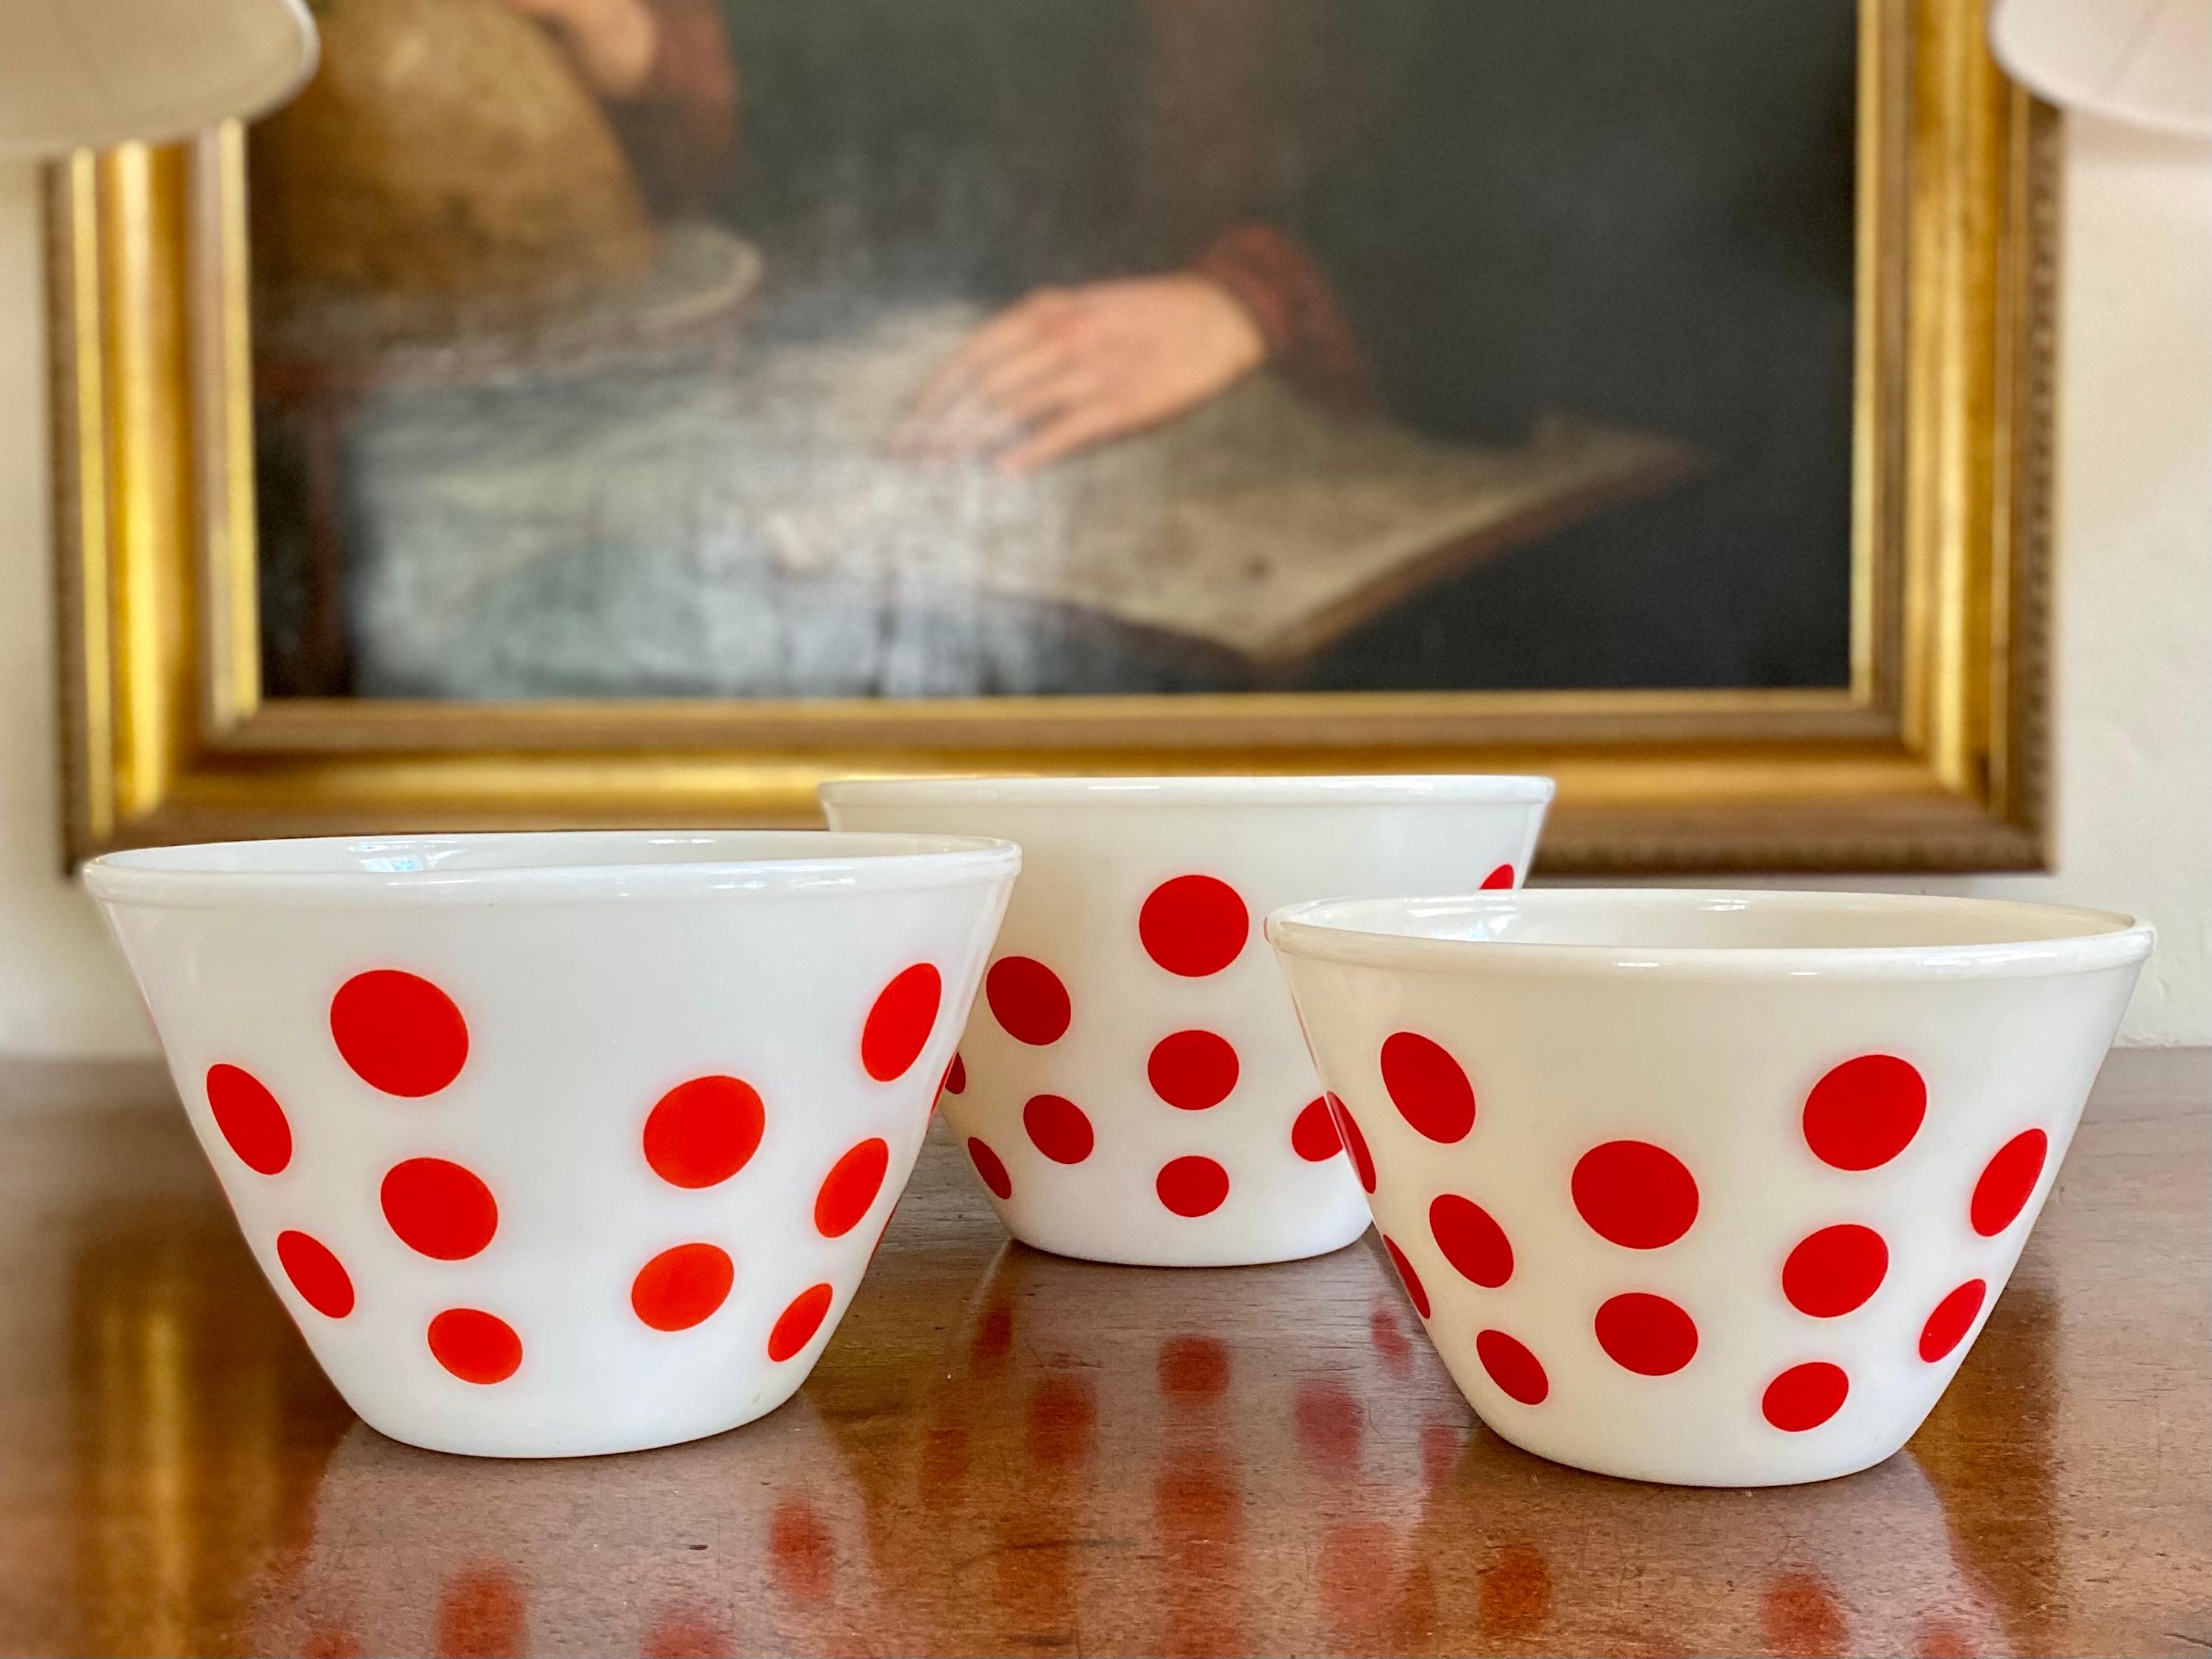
xmin=0 ymin=0 xmax=316 ymax=154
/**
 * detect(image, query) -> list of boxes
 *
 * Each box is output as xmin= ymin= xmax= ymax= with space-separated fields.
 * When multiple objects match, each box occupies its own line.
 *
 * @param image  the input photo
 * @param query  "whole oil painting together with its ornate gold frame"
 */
xmin=51 ymin=0 xmax=2055 ymax=874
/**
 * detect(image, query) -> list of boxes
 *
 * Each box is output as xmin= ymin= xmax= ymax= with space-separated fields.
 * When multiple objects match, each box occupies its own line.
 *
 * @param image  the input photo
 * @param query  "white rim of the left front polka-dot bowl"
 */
xmin=82 ymin=830 xmax=1022 ymax=907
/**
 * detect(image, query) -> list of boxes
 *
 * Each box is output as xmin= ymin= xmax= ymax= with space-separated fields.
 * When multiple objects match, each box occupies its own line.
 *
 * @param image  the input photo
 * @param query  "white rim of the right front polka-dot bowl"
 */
xmin=1265 ymin=887 xmax=2155 ymax=982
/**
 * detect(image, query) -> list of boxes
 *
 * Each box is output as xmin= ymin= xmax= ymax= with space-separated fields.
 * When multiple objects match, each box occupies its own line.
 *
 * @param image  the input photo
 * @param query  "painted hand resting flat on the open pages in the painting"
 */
xmin=894 ymin=274 xmax=1267 ymax=473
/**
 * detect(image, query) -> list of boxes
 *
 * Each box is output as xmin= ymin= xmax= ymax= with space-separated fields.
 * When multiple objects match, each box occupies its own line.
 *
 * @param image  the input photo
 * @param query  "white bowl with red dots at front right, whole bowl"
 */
xmin=1267 ymin=889 xmax=2150 ymax=1486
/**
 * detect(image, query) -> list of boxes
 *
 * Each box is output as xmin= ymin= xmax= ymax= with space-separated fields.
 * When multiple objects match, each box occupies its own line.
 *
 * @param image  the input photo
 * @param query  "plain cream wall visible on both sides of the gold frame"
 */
xmin=0 ymin=119 xmax=2212 ymax=1055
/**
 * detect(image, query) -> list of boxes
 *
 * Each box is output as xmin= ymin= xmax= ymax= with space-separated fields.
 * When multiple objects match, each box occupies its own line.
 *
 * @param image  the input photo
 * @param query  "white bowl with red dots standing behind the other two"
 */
xmin=823 ymin=776 xmax=1553 ymax=1268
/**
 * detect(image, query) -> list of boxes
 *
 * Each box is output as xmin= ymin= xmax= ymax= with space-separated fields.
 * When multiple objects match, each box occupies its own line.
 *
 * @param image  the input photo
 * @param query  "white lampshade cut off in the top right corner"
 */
xmin=1988 ymin=0 xmax=2212 ymax=139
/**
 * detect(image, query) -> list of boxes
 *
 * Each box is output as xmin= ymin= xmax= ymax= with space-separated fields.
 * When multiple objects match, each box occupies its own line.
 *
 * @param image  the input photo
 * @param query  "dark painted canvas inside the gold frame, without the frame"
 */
xmin=248 ymin=0 xmax=1858 ymax=699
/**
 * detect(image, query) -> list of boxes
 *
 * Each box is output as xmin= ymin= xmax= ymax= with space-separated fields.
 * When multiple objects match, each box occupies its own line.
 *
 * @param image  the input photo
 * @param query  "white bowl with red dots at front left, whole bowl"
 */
xmin=86 ymin=832 xmax=1020 ymax=1457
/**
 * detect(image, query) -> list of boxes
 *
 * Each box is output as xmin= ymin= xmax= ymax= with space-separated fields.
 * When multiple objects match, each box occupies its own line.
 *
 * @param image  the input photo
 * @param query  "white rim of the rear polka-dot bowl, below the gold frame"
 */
xmin=814 ymin=772 xmax=1557 ymax=807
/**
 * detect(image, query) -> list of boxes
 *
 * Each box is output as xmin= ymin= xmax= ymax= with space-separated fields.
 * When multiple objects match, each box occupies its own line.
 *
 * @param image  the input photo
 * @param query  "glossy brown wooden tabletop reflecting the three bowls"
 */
xmin=0 ymin=1053 xmax=2212 ymax=1655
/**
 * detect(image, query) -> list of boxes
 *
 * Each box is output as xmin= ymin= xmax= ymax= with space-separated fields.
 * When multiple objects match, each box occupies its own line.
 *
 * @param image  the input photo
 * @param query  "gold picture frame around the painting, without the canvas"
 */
xmin=49 ymin=0 xmax=2058 ymax=874
